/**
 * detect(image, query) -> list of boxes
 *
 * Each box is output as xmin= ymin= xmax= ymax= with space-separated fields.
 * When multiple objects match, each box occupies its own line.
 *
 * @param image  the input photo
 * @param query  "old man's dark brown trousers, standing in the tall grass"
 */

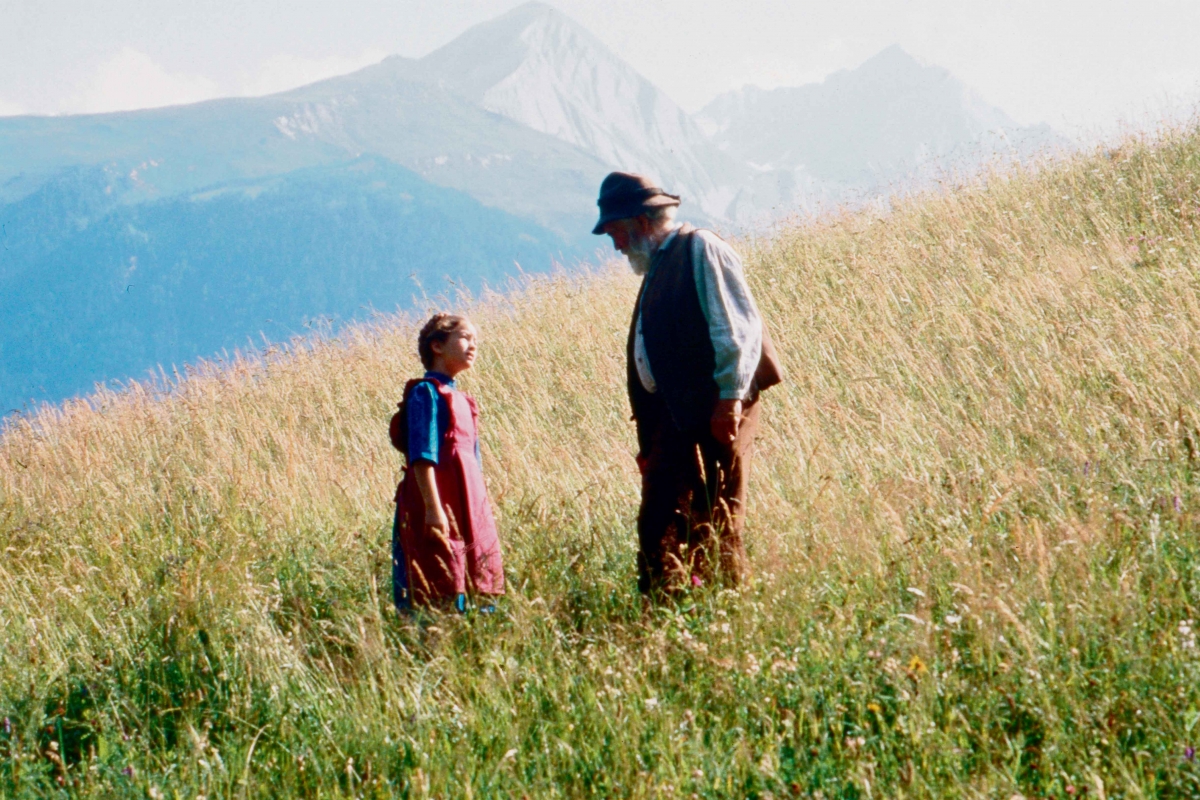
xmin=637 ymin=396 xmax=758 ymax=594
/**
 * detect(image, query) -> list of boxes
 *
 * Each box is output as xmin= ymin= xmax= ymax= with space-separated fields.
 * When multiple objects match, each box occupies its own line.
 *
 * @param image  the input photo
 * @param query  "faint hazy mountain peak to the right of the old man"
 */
xmin=696 ymin=46 xmax=1061 ymax=216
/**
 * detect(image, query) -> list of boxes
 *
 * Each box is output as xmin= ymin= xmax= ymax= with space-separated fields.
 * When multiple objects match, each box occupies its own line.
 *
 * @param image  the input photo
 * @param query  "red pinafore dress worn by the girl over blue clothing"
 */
xmin=394 ymin=378 xmax=504 ymax=606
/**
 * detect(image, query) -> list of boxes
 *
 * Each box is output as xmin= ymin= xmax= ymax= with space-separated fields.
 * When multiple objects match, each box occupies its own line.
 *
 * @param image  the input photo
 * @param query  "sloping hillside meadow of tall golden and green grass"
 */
xmin=0 ymin=131 xmax=1200 ymax=798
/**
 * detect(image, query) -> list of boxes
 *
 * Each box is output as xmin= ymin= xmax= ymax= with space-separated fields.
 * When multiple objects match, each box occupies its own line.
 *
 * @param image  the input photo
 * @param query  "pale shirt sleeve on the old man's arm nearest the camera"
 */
xmin=692 ymin=230 xmax=762 ymax=399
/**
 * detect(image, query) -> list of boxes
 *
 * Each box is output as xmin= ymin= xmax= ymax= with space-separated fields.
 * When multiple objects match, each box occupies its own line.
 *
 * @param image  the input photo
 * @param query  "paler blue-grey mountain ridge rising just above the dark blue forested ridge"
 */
xmin=0 ymin=58 xmax=607 ymax=241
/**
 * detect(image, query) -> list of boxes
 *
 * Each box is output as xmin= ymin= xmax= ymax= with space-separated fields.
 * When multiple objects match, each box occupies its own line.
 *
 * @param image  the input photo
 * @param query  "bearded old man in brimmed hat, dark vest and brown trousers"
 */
xmin=592 ymin=173 xmax=780 ymax=595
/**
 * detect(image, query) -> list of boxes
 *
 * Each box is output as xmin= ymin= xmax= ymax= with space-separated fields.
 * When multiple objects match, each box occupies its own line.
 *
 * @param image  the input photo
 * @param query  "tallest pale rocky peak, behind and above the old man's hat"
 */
xmin=420 ymin=2 xmax=739 ymax=217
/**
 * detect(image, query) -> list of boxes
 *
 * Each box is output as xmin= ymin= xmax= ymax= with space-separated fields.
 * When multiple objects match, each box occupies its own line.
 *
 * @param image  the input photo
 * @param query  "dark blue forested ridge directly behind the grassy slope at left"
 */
xmin=0 ymin=155 xmax=580 ymax=414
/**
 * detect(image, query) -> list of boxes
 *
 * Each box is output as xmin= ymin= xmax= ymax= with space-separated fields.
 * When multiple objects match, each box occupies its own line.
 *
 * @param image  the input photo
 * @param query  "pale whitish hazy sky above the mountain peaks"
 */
xmin=0 ymin=0 xmax=1200 ymax=134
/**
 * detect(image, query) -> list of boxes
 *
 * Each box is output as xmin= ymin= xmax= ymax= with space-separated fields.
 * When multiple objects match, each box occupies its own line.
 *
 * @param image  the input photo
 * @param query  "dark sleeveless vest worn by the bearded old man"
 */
xmin=626 ymin=224 xmax=780 ymax=438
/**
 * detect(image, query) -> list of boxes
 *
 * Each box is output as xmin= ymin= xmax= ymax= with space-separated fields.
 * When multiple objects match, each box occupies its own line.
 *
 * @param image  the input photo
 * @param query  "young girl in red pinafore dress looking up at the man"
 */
xmin=392 ymin=314 xmax=504 ymax=612
